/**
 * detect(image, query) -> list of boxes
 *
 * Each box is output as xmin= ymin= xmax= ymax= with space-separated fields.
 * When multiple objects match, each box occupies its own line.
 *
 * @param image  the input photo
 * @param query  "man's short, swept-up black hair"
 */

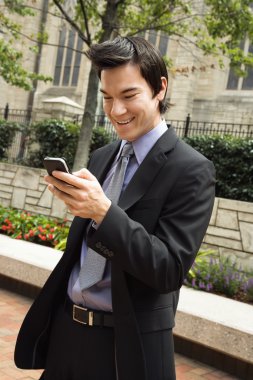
xmin=87 ymin=37 xmax=168 ymax=114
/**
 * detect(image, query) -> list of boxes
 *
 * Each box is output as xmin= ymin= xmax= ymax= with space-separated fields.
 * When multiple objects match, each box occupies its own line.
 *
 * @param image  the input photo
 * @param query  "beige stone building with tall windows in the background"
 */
xmin=0 ymin=0 xmax=253 ymax=124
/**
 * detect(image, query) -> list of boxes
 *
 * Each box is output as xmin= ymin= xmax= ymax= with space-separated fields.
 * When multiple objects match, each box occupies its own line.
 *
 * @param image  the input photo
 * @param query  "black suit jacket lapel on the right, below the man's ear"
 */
xmin=118 ymin=127 xmax=178 ymax=210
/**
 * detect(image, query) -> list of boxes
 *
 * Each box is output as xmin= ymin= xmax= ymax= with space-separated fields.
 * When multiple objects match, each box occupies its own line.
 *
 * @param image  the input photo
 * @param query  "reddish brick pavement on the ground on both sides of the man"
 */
xmin=0 ymin=289 xmax=237 ymax=380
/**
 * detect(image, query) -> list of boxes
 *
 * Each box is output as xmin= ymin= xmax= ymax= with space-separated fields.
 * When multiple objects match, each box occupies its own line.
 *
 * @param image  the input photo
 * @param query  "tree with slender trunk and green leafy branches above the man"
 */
xmin=0 ymin=0 xmax=253 ymax=169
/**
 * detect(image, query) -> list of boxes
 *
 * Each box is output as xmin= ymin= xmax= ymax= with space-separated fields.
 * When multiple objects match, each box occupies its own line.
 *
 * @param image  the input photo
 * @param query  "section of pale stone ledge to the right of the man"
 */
xmin=174 ymin=287 xmax=253 ymax=364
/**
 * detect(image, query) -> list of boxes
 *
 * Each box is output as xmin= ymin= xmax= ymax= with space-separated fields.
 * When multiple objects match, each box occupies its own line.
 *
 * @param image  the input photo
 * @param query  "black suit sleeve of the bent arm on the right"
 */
xmin=88 ymin=159 xmax=215 ymax=293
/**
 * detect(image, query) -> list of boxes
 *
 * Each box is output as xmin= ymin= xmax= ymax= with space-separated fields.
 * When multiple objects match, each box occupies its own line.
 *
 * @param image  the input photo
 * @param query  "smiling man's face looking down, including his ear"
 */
xmin=101 ymin=63 xmax=167 ymax=141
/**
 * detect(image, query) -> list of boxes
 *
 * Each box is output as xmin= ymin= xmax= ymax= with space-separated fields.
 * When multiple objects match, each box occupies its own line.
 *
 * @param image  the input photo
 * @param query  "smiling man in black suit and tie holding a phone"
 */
xmin=15 ymin=37 xmax=215 ymax=380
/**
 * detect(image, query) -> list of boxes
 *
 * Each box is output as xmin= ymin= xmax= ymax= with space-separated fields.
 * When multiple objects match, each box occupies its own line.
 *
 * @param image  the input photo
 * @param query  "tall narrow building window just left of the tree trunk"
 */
xmin=54 ymin=27 xmax=83 ymax=86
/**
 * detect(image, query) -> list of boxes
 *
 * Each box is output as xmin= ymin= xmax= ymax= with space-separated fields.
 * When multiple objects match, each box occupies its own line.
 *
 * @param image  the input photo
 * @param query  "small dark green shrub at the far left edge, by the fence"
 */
xmin=0 ymin=120 xmax=21 ymax=160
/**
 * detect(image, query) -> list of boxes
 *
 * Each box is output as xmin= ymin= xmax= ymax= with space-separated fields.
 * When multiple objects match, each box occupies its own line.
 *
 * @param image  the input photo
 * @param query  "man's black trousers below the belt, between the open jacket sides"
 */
xmin=41 ymin=306 xmax=116 ymax=380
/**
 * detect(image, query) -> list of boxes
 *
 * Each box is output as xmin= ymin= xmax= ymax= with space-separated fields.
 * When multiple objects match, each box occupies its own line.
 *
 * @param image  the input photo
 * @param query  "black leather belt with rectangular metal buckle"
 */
xmin=65 ymin=297 xmax=114 ymax=327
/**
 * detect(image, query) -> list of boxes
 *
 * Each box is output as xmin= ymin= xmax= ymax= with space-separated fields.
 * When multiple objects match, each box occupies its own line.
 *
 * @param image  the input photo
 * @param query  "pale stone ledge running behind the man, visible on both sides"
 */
xmin=0 ymin=235 xmax=253 ymax=365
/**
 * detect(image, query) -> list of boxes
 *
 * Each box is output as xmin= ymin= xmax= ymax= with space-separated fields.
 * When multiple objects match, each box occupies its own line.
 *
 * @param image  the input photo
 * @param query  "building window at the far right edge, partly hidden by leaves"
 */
xmin=227 ymin=39 xmax=253 ymax=91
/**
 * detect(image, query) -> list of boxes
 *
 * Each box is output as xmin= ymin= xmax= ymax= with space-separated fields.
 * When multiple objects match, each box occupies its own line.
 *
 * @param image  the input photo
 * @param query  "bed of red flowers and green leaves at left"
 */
xmin=0 ymin=206 xmax=69 ymax=247
